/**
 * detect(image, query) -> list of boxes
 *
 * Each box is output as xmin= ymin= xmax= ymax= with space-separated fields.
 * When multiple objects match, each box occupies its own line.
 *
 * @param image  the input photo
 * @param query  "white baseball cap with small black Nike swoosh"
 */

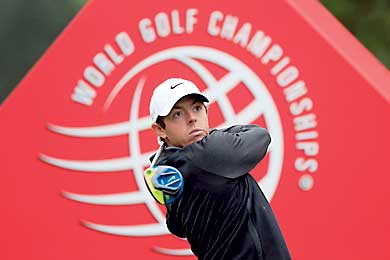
xmin=149 ymin=78 xmax=209 ymax=122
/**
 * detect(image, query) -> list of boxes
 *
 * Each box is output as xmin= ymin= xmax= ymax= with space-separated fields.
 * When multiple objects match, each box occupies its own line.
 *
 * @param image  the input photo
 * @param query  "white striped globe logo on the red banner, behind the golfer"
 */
xmin=40 ymin=46 xmax=284 ymax=256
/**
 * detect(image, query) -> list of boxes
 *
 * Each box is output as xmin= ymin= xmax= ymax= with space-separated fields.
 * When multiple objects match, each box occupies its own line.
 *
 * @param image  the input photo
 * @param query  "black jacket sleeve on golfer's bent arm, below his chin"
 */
xmin=183 ymin=125 xmax=271 ymax=178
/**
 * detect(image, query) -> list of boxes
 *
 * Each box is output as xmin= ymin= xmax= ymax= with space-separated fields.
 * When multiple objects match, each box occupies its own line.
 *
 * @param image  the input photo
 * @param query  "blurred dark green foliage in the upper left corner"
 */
xmin=0 ymin=0 xmax=86 ymax=102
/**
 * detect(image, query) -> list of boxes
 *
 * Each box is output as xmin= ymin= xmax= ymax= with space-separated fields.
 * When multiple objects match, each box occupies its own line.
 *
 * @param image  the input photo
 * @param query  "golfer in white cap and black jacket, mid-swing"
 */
xmin=150 ymin=78 xmax=290 ymax=260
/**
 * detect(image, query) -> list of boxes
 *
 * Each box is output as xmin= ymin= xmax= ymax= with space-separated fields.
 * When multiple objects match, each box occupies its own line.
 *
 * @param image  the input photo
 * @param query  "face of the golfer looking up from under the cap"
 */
xmin=152 ymin=95 xmax=210 ymax=147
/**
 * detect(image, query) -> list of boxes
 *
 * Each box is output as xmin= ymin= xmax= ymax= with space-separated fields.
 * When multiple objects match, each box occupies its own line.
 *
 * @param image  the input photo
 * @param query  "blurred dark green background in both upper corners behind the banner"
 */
xmin=0 ymin=0 xmax=390 ymax=103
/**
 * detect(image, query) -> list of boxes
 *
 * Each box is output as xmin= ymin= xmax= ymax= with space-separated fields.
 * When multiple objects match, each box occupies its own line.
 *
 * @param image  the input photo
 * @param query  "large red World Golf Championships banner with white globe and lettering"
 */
xmin=0 ymin=0 xmax=390 ymax=260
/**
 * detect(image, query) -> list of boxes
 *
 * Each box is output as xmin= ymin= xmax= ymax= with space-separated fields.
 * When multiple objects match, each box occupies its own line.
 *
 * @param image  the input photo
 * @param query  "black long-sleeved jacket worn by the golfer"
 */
xmin=156 ymin=125 xmax=290 ymax=260
